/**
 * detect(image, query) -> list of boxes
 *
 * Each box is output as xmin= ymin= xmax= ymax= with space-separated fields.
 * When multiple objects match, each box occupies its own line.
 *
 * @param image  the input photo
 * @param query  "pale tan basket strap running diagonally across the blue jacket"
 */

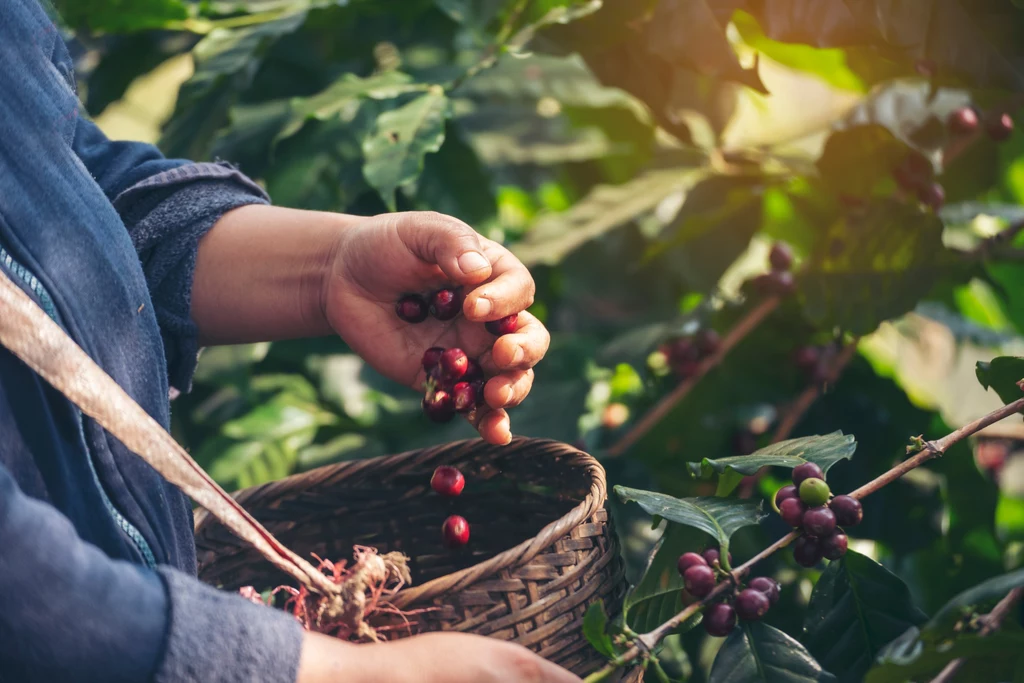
xmin=0 ymin=270 xmax=338 ymax=595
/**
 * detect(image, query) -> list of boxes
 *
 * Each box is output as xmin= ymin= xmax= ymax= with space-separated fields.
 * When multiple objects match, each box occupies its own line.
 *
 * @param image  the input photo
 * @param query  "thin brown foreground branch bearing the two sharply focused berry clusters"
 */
xmin=584 ymin=393 xmax=1024 ymax=683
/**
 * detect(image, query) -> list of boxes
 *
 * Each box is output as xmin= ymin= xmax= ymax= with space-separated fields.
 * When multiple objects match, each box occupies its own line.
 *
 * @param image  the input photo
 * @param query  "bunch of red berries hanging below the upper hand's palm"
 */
xmin=423 ymin=346 xmax=485 ymax=422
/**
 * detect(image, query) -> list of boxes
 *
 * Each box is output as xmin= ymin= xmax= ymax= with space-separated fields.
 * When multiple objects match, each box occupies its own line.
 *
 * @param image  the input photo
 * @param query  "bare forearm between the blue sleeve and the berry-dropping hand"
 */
xmin=191 ymin=205 xmax=357 ymax=345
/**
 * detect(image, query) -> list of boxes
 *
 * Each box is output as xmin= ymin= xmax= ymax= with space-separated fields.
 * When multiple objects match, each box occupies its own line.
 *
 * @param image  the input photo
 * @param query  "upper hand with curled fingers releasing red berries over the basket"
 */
xmin=321 ymin=212 xmax=551 ymax=444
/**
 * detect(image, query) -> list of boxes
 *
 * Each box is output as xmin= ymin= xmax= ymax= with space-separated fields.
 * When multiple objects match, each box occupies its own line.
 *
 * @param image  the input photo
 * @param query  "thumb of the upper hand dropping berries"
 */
xmin=397 ymin=211 xmax=490 ymax=285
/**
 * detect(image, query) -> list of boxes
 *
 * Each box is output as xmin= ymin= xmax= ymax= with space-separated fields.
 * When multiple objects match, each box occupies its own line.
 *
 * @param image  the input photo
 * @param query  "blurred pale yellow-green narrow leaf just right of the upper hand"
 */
xmin=512 ymin=168 xmax=706 ymax=265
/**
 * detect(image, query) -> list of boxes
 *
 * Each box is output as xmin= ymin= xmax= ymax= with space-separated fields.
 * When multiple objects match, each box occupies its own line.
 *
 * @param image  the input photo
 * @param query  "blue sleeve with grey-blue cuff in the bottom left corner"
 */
xmin=0 ymin=466 xmax=302 ymax=683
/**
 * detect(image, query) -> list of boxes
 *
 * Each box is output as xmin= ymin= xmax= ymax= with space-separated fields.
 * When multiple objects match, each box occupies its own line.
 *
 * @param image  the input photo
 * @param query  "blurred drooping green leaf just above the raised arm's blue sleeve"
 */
xmin=160 ymin=11 xmax=306 ymax=160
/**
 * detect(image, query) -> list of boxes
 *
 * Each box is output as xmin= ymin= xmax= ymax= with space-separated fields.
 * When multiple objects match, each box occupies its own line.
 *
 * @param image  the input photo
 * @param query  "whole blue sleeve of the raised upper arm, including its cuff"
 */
xmin=73 ymin=118 xmax=269 ymax=391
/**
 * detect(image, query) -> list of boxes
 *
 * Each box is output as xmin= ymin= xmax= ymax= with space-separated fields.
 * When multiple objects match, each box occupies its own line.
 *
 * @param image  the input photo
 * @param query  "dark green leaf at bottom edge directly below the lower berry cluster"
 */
xmin=708 ymin=622 xmax=836 ymax=683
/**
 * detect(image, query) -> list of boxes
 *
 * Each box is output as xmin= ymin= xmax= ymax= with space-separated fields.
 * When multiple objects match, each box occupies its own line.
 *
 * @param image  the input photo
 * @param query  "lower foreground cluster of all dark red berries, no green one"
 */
xmin=676 ymin=548 xmax=780 ymax=638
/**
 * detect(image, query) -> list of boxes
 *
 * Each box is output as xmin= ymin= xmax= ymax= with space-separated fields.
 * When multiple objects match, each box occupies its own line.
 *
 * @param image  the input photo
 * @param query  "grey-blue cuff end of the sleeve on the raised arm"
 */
xmin=114 ymin=163 xmax=269 ymax=392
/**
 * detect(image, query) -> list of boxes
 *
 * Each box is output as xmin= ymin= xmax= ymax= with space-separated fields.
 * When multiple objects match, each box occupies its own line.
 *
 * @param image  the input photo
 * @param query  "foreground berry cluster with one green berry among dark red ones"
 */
xmin=775 ymin=463 xmax=864 ymax=567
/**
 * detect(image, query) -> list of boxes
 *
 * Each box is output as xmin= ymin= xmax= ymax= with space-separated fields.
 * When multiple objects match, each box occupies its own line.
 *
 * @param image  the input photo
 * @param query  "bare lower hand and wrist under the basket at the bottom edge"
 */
xmin=296 ymin=632 xmax=581 ymax=683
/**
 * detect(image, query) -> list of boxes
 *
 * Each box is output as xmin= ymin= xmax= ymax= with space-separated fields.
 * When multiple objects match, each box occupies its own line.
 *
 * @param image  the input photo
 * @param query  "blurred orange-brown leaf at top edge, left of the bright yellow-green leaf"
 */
xmin=646 ymin=0 xmax=768 ymax=94
